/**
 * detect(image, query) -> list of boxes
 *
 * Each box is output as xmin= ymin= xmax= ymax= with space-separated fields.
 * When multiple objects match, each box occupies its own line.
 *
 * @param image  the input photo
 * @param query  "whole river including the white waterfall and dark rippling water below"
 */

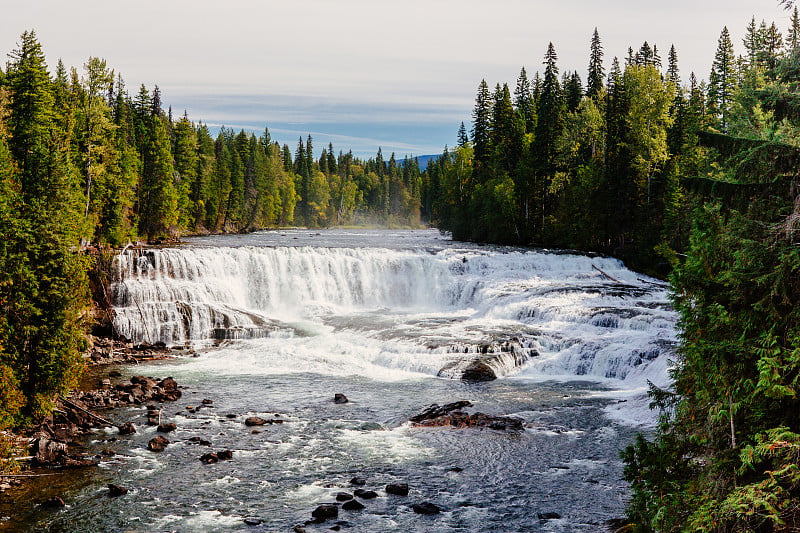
xmin=0 ymin=230 xmax=676 ymax=532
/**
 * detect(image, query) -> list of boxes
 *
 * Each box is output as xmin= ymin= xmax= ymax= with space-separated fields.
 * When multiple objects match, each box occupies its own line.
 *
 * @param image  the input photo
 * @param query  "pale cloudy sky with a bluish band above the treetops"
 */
xmin=0 ymin=0 xmax=789 ymax=157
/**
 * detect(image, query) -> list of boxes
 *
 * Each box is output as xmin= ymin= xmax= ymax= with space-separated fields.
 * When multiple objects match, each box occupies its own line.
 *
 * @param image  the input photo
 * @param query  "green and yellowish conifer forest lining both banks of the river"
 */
xmin=0 ymin=4 xmax=800 ymax=532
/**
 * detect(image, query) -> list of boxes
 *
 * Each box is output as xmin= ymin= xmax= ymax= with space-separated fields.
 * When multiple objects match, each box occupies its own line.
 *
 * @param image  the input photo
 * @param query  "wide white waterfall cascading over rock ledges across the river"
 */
xmin=112 ymin=239 xmax=676 ymax=388
